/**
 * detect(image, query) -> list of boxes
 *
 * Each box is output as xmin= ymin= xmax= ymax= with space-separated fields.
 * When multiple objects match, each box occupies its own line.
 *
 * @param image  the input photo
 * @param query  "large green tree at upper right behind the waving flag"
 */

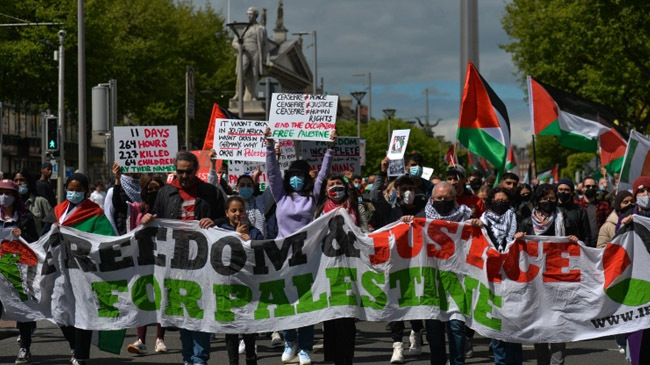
xmin=502 ymin=0 xmax=650 ymax=133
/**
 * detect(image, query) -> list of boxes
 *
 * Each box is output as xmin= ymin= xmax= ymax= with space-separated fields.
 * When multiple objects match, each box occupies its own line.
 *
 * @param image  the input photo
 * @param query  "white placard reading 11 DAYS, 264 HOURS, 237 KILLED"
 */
xmin=114 ymin=125 xmax=178 ymax=173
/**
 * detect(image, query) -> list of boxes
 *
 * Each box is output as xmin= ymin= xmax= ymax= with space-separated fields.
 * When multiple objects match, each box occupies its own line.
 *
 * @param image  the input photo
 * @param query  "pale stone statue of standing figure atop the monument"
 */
xmin=232 ymin=6 xmax=268 ymax=101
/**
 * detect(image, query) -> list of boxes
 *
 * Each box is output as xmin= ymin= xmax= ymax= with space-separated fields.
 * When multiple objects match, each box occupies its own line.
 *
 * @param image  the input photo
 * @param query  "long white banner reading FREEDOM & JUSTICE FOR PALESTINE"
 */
xmin=0 ymin=210 xmax=650 ymax=343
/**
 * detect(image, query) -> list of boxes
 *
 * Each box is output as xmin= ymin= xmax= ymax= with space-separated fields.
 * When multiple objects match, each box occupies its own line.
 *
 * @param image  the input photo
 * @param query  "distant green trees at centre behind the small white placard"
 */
xmin=336 ymin=118 xmax=449 ymax=176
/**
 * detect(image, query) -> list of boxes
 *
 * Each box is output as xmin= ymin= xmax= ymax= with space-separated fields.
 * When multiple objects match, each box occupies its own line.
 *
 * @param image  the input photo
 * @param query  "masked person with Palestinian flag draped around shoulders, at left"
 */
xmin=46 ymin=173 xmax=116 ymax=365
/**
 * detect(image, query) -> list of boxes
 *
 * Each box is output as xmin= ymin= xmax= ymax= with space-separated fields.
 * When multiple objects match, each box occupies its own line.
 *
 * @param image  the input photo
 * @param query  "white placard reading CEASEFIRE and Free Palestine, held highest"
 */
xmin=269 ymin=93 xmax=339 ymax=141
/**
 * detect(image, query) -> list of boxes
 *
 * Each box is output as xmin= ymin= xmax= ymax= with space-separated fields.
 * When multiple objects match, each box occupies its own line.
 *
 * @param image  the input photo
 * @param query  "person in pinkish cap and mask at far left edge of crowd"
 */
xmin=0 ymin=179 xmax=38 ymax=364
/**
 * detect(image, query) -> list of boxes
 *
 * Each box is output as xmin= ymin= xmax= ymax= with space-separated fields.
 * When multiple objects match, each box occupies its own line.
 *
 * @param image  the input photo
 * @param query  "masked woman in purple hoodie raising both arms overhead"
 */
xmin=264 ymin=127 xmax=336 ymax=365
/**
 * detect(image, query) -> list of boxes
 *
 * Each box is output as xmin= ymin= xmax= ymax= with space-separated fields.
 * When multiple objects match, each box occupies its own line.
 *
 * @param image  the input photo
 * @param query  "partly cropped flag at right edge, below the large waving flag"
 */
xmin=618 ymin=130 xmax=650 ymax=191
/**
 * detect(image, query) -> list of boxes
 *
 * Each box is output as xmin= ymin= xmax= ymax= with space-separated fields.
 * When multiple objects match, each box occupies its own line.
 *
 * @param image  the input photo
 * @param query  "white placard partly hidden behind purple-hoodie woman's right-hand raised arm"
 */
xmin=301 ymin=137 xmax=361 ymax=174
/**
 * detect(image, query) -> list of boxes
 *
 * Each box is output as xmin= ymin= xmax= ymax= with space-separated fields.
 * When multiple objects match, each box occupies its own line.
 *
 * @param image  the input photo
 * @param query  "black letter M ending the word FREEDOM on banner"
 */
xmin=251 ymin=232 xmax=307 ymax=275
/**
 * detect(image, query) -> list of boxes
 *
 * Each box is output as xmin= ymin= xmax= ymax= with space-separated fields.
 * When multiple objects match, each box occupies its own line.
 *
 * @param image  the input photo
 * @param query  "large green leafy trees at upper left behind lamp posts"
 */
xmin=0 ymin=0 xmax=235 ymax=145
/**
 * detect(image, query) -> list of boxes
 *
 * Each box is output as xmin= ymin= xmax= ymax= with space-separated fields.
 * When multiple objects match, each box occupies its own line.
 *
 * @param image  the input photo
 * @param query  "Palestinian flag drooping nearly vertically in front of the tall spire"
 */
xmin=456 ymin=62 xmax=510 ymax=176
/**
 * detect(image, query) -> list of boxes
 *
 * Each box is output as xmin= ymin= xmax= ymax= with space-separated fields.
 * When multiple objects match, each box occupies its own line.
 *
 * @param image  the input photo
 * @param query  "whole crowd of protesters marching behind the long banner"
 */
xmin=0 ymin=134 xmax=650 ymax=365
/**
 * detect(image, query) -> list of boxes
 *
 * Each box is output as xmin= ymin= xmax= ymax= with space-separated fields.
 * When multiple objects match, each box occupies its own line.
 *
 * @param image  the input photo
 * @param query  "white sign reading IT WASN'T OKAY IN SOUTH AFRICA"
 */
xmin=213 ymin=119 xmax=267 ymax=162
